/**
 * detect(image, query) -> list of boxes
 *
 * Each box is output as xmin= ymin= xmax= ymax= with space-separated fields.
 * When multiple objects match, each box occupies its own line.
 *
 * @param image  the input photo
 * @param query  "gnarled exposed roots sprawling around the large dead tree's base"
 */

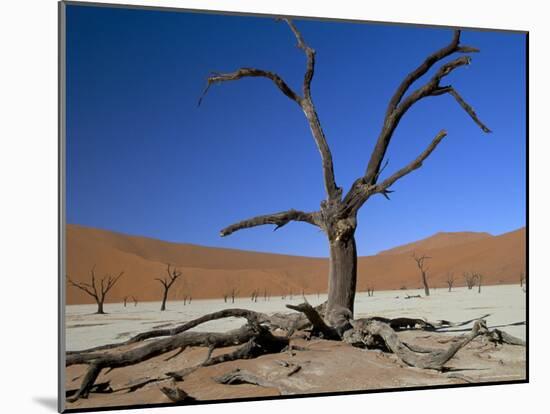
xmin=66 ymin=302 xmax=525 ymax=402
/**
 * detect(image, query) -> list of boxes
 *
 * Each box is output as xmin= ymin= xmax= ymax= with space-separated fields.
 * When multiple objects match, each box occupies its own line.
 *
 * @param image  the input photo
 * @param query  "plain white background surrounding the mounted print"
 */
xmin=0 ymin=0 xmax=550 ymax=414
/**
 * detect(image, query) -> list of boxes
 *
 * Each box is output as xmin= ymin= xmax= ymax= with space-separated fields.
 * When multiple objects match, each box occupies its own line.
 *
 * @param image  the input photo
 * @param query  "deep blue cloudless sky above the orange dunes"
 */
xmin=67 ymin=5 xmax=526 ymax=256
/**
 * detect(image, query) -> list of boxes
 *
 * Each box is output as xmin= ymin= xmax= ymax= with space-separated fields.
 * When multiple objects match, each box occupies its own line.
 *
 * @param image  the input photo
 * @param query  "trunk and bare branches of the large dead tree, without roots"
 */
xmin=199 ymin=18 xmax=490 ymax=326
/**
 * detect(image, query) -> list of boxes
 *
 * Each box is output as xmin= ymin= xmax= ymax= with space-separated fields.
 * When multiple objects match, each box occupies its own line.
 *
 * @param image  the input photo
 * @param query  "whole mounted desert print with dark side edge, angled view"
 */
xmin=59 ymin=2 xmax=528 ymax=412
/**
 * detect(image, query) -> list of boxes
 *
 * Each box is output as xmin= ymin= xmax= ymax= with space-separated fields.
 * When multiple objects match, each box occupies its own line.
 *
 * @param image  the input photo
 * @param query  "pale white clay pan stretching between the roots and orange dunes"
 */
xmin=66 ymin=285 xmax=526 ymax=351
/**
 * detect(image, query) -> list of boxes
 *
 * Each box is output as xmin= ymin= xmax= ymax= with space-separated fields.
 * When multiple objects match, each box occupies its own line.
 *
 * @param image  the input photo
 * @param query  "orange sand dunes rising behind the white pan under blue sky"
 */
xmin=67 ymin=225 xmax=526 ymax=304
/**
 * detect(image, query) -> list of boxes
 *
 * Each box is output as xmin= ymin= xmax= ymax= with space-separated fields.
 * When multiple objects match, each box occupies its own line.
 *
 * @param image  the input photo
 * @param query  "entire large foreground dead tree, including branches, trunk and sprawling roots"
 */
xmin=66 ymin=19 xmax=504 ymax=400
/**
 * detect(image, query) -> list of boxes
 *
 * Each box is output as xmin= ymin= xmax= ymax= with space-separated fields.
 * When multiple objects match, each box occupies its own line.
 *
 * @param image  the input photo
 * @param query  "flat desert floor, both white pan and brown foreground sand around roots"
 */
xmin=66 ymin=285 xmax=526 ymax=408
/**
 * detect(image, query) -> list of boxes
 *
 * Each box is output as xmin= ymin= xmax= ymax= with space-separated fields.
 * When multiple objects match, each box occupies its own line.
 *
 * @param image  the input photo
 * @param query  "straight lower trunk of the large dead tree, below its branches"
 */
xmin=327 ymin=235 xmax=357 ymax=315
